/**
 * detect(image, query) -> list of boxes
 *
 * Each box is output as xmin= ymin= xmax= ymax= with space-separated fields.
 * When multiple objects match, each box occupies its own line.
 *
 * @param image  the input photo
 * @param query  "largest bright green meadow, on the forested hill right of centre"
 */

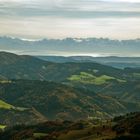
xmin=68 ymin=72 xmax=126 ymax=85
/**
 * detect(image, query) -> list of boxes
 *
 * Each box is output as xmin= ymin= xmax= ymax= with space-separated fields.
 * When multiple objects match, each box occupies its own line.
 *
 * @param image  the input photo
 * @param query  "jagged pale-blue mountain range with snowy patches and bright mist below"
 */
xmin=0 ymin=37 xmax=140 ymax=57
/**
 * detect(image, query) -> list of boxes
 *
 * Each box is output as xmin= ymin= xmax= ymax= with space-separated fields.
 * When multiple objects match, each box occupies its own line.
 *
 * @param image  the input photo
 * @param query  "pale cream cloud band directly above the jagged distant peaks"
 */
xmin=0 ymin=17 xmax=140 ymax=39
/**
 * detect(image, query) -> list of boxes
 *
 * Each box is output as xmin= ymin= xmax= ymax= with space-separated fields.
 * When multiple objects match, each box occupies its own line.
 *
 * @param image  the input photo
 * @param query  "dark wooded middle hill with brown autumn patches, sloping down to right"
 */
xmin=0 ymin=80 xmax=139 ymax=124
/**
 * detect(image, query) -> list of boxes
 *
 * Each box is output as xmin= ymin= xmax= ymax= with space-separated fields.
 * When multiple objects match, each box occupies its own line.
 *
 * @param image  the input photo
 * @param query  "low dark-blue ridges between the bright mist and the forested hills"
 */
xmin=37 ymin=56 xmax=140 ymax=68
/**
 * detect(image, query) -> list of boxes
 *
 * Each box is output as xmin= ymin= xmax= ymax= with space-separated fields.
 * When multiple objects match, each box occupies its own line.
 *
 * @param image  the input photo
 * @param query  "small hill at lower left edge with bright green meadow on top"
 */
xmin=0 ymin=97 xmax=47 ymax=129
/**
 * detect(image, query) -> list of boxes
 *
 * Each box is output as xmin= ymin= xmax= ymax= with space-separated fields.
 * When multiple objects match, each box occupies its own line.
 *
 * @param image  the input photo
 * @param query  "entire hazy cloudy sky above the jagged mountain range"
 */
xmin=0 ymin=0 xmax=140 ymax=39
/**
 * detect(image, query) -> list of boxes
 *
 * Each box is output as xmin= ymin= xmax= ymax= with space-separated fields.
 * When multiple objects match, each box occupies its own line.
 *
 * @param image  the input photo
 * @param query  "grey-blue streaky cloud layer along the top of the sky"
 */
xmin=0 ymin=0 xmax=140 ymax=18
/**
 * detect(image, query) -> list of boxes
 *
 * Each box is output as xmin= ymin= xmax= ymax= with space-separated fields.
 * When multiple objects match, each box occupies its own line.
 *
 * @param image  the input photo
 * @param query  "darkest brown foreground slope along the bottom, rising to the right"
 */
xmin=0 ymin=113 xmax=140 ymax=140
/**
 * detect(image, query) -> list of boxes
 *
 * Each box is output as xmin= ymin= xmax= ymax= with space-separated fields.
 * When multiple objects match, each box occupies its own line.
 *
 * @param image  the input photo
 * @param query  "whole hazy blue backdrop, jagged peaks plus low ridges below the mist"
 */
xmin=0 ymin=37 xmax=140 ymax=68
